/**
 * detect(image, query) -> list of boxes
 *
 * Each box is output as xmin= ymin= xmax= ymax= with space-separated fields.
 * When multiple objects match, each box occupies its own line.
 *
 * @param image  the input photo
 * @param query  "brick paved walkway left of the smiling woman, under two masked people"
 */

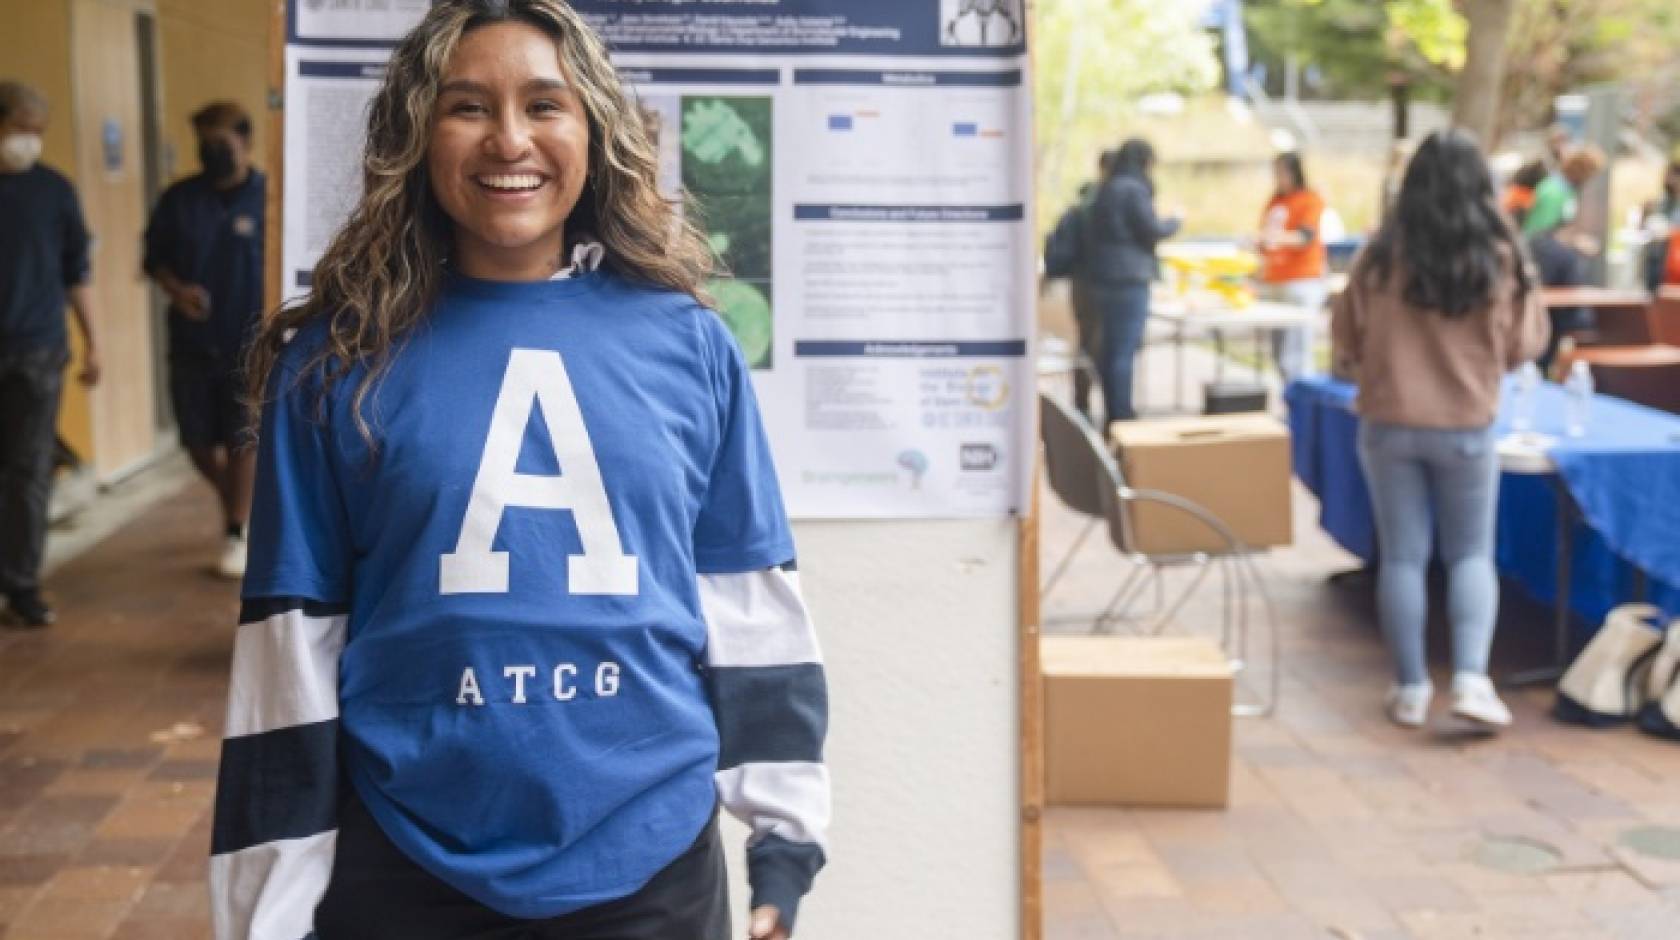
xmin=0 ymin=487 xmax=237 ymax=940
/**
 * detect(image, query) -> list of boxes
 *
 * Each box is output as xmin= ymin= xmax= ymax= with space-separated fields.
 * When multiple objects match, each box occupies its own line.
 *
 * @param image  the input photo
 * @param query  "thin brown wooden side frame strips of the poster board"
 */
xmin=264 ymin=0 xmax=1043 ymax=940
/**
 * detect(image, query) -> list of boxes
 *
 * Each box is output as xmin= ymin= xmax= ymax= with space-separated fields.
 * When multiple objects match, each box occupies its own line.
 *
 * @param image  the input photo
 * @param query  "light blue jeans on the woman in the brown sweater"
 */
xmin=1359 ymin=421 xmax=1499 ymax=685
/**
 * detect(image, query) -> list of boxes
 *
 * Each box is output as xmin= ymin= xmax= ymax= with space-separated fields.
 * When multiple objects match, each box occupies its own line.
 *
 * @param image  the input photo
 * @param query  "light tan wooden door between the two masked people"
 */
xmin=67 ymin=0 xmax=156 ymax=480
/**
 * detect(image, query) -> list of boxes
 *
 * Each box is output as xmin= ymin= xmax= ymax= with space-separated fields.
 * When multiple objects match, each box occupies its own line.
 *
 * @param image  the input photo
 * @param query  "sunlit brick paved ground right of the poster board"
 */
xmin=1043 ymin=436 xmax=1680 ymax=940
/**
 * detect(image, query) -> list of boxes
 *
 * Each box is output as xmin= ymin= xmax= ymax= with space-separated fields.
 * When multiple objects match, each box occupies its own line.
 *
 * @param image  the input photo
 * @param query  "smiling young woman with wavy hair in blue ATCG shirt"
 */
xmin=210 ymin=0 xmax=828 ymax=940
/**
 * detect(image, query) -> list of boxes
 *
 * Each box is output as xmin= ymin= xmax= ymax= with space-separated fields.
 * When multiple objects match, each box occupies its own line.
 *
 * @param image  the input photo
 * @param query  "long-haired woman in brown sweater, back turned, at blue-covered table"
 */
xmin=1331 ymin=131 xmax=1549 ymax=727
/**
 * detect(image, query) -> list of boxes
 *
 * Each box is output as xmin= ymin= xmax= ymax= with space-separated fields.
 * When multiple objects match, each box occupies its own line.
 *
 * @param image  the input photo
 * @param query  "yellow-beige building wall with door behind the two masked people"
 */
xmin=0 ymin=0 xmax=281 ymax=478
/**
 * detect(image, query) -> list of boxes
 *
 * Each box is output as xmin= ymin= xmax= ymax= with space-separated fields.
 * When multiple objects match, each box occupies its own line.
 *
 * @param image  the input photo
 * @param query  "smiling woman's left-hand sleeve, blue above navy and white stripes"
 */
xmin=210 ymin=354 xmax=349 ymax=940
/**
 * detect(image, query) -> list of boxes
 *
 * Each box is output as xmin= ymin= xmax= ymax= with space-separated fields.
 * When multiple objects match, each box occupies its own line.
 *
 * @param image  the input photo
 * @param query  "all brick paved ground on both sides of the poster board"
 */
xmin=0 ymin=355 xmax=1680 ymax=940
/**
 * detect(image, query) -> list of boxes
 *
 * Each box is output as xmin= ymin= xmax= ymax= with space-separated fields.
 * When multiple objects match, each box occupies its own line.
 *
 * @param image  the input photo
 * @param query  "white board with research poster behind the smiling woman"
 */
xmin=274 ymin=0 xmax=1042 ymax=940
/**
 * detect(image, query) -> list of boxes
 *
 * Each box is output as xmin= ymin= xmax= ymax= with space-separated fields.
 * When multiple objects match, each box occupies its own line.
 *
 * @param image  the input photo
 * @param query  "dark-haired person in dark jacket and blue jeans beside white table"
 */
xmin=1074 ymin=138 xmax=1179 ymax=421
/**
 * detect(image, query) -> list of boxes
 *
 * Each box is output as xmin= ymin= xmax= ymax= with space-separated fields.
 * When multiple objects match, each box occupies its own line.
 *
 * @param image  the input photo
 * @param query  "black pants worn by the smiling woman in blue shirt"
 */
xmin=316 ymin=787 xmax=731 ymax=940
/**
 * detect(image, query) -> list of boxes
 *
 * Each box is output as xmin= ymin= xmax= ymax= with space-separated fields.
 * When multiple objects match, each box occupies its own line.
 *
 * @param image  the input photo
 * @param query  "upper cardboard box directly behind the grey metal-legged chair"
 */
xmin=1109 ymin=415 xmax=1294 ymax=554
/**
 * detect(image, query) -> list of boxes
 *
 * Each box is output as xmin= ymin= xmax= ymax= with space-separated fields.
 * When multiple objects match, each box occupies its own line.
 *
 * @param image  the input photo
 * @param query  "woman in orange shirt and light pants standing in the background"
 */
xmin=1260 ymin=153 xmax=1326 ymax=379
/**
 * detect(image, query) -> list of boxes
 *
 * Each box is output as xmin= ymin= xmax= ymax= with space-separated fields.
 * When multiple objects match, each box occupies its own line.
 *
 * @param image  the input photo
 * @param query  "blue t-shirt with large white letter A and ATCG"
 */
xmin=244 ymin=270 xmax=793 ymax=918
